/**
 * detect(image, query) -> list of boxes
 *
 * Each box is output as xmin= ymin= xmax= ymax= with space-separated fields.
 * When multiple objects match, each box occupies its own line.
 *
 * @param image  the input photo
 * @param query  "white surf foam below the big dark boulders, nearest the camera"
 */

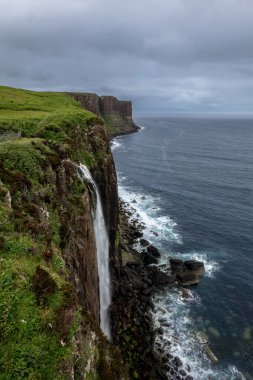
xmin=154 ymin=289 xmax=244 ymax=380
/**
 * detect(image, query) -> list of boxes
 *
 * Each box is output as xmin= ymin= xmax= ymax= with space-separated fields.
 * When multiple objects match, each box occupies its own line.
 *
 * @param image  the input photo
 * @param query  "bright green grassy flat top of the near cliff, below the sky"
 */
xmin=0 ymin=86 xmax=101 ymax=142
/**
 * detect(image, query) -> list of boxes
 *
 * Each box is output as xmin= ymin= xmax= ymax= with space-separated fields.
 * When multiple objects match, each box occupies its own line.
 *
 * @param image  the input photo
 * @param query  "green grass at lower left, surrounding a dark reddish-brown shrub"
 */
xmin=0 ymin=242 xmax=70 ymax=380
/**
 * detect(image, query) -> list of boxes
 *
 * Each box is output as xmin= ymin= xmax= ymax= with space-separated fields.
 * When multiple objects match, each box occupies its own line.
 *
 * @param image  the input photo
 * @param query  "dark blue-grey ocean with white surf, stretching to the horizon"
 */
xmin=113 ymin=116 xmax=253 ymax=380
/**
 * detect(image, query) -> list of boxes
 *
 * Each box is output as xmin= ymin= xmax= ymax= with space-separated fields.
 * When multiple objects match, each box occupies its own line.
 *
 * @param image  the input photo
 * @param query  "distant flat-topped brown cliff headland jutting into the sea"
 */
xmin=68 ymin=92 xmax=139 ymax=137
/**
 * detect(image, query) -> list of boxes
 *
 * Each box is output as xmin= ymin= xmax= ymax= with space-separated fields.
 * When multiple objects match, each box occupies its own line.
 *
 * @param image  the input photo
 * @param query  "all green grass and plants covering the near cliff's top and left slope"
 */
xmin=0 ymin=86 xmax=101 ymax=380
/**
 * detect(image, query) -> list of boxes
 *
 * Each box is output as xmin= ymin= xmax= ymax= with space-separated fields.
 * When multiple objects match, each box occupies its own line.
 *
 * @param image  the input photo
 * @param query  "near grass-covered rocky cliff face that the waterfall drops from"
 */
xmin=0 ymin=87 xmax=126 ymax=380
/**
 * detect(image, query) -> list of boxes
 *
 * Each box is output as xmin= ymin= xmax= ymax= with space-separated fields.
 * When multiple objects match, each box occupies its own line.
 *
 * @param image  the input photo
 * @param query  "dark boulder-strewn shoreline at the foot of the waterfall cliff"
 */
xmin=111 ymin=200 xmax=205 ymax=380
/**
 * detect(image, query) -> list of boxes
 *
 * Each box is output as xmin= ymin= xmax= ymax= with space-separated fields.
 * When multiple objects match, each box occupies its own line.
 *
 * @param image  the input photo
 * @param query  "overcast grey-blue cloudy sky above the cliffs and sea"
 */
xmin=0 ymin=0 xmax=253 ymax=113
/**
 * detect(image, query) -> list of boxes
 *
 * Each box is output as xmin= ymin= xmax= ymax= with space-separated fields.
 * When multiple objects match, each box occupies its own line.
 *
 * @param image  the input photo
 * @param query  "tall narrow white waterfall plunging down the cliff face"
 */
xmin=78 ymin=164 xmax=111 ymax=338
